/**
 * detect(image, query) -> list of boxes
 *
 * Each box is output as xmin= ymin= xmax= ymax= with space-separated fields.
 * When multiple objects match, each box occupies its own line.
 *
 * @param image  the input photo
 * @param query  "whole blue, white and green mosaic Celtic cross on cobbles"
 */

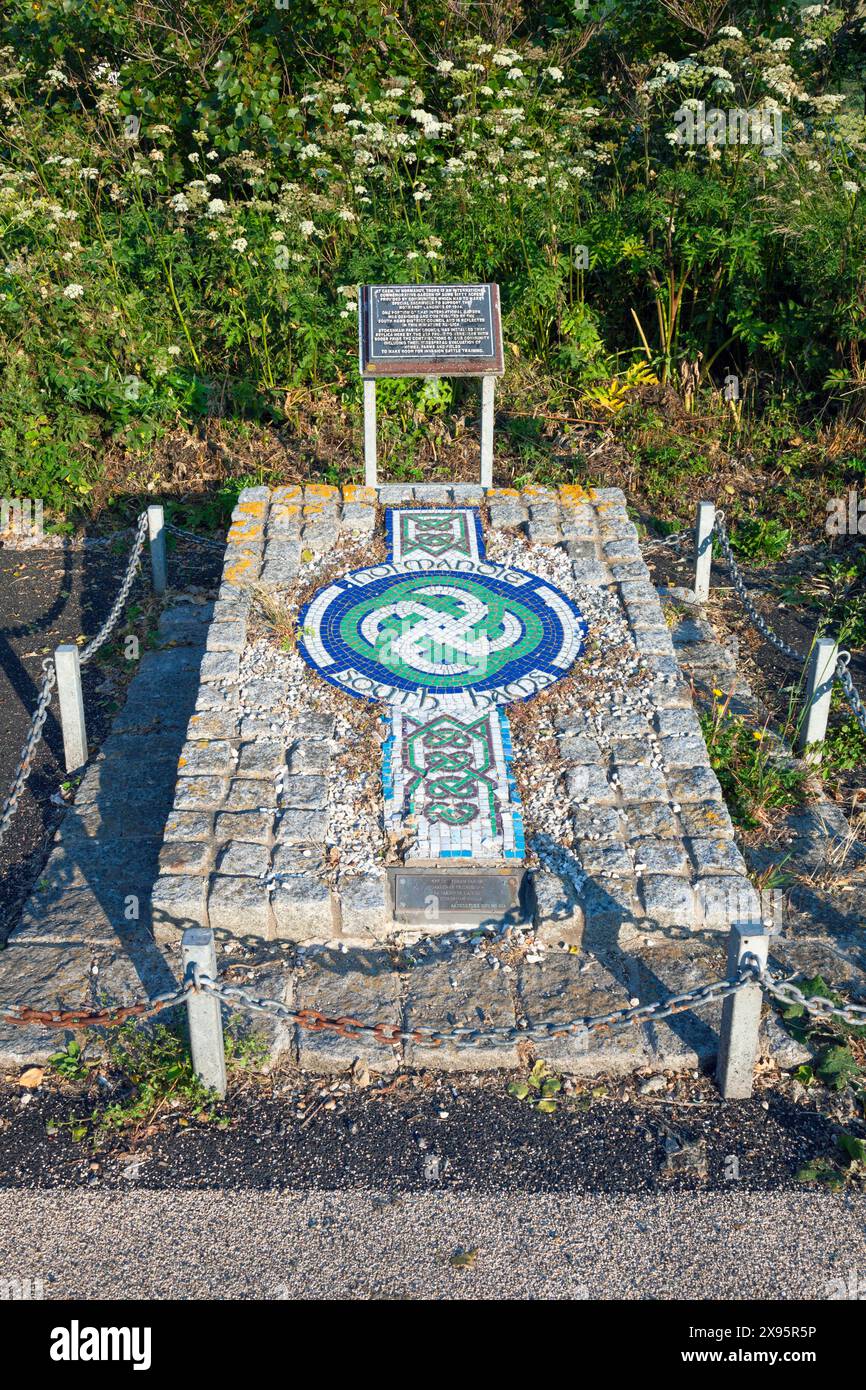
xmin=299 ymin=507 xmax=587 ymax=863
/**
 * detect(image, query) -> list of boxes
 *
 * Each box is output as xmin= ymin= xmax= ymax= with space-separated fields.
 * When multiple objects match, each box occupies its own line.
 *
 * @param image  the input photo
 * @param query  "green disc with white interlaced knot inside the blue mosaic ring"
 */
xmin=339 ymin=574 xmax=544 ymax=689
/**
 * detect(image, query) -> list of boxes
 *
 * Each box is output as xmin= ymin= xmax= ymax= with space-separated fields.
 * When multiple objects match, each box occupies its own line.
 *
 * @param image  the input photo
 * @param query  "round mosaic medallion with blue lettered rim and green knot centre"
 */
xmin=299 ymin=560 xmax=587 ymax=705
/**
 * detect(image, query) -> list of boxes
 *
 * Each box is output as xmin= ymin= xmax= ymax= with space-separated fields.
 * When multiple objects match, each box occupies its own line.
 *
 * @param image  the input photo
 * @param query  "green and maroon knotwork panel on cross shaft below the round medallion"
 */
xmin=406 ymin=714 xmax=496 ymax=826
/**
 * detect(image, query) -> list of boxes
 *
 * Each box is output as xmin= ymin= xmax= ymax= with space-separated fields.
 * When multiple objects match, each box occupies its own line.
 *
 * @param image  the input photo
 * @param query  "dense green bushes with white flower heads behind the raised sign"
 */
xmin=0 ymin=0 xmax=866 ymax=510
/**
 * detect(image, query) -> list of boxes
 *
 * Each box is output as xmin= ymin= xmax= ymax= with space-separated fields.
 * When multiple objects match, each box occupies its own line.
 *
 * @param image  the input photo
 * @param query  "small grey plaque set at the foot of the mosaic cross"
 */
xmin=391 ymin=867 xmax=523 ymax=927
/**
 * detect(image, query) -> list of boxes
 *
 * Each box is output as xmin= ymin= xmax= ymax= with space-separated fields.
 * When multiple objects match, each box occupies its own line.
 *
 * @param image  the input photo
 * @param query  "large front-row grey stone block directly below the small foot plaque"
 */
xmin=403 ymin=952 xmax=518 ymax=1072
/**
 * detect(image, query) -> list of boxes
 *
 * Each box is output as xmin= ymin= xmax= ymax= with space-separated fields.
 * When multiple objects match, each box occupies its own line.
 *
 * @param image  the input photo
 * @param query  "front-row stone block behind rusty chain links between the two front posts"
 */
xmin=295 ymin=949 xmax=402 ymax=1073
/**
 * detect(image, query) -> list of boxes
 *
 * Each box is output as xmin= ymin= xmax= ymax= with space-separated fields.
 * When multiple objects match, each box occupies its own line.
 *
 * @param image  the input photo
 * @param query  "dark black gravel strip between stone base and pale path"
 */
xmin=0 ymin=1073 xmax=859 ymax=1193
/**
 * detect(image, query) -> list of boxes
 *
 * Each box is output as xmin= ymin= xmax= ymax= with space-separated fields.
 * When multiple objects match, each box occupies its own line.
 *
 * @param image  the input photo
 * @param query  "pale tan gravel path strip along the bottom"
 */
xmin=0 ymin=1190 xmax=866 ymax=1301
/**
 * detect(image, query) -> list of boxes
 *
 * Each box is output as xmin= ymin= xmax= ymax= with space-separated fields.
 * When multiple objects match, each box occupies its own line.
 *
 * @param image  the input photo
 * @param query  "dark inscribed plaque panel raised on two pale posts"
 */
xmin=359 ymin=285 xmax=505 ymax=379
